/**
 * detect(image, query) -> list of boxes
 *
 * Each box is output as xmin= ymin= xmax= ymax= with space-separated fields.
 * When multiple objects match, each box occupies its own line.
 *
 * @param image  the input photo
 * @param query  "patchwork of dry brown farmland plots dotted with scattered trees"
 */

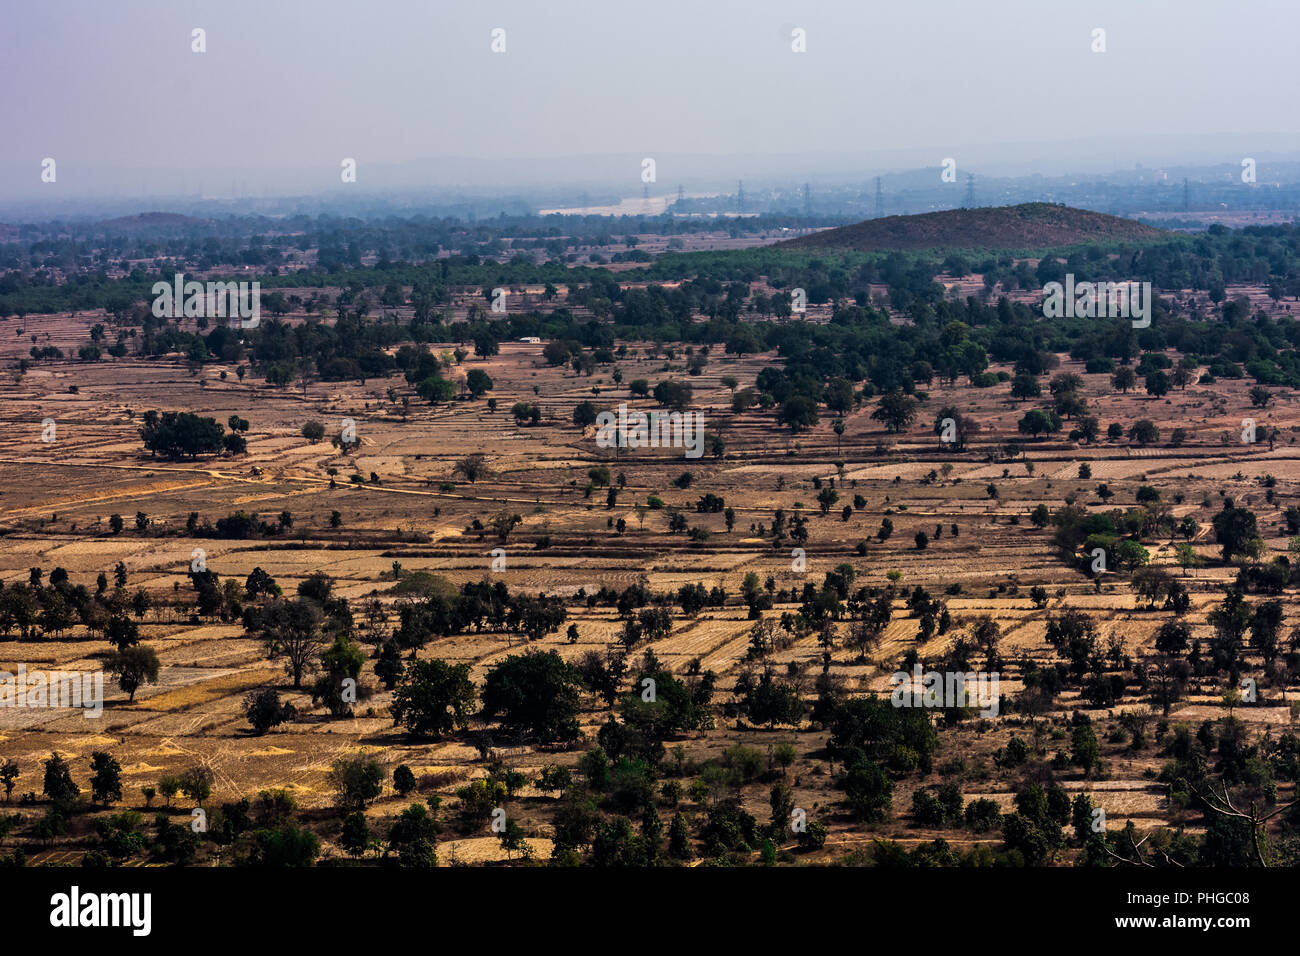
xmin=0 ymin=240 xmax=1300 ymax=865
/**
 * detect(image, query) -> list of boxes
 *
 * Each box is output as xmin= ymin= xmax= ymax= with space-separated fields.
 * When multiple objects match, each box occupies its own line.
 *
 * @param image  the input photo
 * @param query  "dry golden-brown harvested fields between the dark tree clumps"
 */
xmin=0 ymin=287 xmax=1300 ymax=865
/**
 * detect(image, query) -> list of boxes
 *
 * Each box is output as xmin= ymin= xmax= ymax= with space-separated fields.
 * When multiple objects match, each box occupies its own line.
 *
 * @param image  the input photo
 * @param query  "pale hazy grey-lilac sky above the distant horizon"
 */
xmin=0 ymin=0 xmax=1300 ymax=198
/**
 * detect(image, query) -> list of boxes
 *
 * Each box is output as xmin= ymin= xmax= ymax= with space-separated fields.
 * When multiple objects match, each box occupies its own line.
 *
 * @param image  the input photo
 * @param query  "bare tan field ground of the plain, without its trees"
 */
xmin=0 ymin=287 xmax=1300 ymax=864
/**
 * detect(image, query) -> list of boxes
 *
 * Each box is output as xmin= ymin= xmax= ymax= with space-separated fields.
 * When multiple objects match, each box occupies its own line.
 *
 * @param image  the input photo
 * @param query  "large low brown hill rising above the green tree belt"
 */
xmin=777 ymin=203 xmax=1169 ymax=252
